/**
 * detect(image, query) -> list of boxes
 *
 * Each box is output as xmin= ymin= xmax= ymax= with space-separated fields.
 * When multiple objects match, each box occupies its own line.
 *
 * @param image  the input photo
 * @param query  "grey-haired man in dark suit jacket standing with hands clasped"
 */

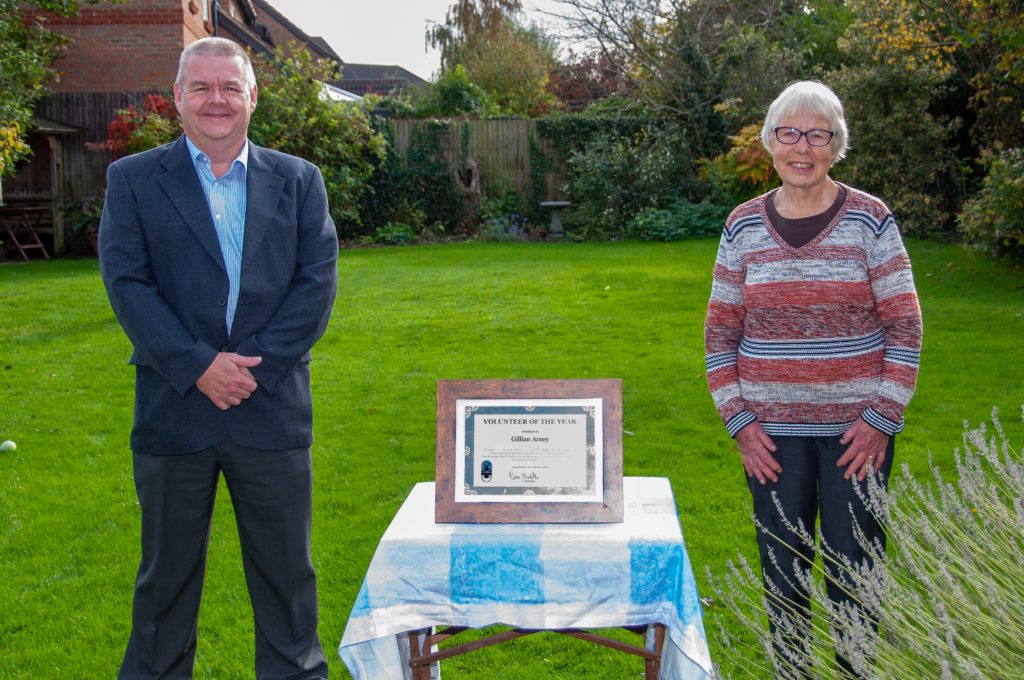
xmin=100 ymin=38 xmax=338 ymax=678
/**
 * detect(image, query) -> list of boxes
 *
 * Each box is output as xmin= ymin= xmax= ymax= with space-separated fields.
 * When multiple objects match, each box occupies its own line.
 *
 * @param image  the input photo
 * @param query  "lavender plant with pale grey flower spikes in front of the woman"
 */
xmin=708 ymin=410 xmax=1024 ymax=680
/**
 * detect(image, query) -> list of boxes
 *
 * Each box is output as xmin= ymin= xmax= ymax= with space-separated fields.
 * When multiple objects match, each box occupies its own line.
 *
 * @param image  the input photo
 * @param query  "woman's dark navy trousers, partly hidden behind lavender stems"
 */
xmin=748 ymin=436 xmax=895 ymax=672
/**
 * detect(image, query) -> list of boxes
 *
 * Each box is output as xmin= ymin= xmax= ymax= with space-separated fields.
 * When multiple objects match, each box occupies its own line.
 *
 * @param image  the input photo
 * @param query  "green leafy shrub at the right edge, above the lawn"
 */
xmin=958 ymin=148 xmax=1024 ymax=258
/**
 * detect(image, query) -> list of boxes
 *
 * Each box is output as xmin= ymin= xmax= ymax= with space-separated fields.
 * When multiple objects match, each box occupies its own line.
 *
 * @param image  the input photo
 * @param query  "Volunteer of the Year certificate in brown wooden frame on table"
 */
xmin=434 ymin=380 xmax=623 ymax=523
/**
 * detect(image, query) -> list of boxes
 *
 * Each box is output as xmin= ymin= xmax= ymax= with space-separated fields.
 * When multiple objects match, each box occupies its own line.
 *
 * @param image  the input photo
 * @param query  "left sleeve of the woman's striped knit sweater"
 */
xmin=705 ymin=227 xmax=756 ymax=436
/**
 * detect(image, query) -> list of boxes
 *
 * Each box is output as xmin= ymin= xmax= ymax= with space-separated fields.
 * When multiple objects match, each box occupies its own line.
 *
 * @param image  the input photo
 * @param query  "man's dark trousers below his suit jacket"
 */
xmin=118 ymin=439 xmax=328 ymax=680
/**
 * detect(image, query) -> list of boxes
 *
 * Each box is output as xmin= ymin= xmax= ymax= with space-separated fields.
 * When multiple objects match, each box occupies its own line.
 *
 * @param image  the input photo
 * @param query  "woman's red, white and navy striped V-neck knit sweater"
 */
xmin=705 ymin=183 xmax=922 ymax=436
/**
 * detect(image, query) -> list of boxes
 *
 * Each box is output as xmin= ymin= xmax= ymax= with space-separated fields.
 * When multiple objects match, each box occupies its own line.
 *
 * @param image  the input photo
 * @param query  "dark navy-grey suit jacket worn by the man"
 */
xmin=99 ymin=136 xmax=338 ymax=454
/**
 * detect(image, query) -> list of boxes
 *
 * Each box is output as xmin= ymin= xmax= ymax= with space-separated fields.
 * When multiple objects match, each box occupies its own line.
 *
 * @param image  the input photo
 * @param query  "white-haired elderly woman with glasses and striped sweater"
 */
xmin=705 ymin=81 xmax=922 ymax=675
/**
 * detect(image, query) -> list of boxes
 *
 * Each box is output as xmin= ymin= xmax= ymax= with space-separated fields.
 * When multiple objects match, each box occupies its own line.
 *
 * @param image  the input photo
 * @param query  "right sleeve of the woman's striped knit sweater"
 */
xmin=861 ymin=215 xmax=923 ymax=436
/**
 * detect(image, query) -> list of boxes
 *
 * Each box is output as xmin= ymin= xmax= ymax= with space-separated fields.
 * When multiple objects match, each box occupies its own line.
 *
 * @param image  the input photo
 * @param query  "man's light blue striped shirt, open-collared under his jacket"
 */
xmin=185 ymin=137 xmax=249 ymax=335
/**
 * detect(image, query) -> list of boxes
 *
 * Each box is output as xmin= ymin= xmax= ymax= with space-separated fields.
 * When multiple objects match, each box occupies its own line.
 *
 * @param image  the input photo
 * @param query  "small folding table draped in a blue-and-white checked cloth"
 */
xmin=338 ymin=477 xmax=712 ymax=680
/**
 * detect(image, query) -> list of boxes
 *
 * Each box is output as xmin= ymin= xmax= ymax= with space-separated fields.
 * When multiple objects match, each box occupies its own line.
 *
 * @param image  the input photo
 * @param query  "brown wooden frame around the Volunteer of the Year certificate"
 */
xmin=434 ymin=378 xmax=623 ymax=524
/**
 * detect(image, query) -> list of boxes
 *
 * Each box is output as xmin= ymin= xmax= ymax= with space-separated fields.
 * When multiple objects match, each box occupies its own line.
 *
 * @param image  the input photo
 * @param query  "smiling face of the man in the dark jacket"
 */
xmin=174 ymin=54 xmax=256 ymax=155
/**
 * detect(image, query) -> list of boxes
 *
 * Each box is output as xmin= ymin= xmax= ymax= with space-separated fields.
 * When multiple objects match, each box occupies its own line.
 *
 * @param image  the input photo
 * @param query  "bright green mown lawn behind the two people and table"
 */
xmin=0 ymin=241 xmax=1024 ymax=680
